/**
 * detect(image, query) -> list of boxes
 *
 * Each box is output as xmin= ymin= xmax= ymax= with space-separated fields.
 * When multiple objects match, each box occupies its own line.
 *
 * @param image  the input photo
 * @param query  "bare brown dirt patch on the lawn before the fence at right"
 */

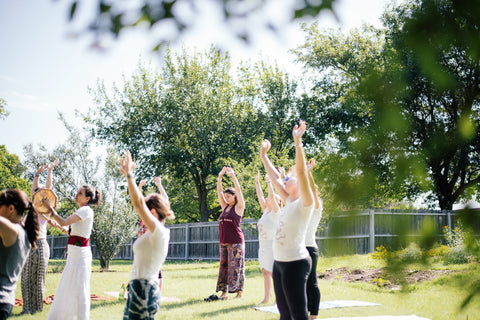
xmin=318 ymin=267 xmax=455 ymax=289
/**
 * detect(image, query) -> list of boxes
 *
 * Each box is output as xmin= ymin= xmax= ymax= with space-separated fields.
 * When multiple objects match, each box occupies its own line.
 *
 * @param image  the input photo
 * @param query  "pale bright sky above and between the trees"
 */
xmin=0 ymin=0 xmax=388 ymax=158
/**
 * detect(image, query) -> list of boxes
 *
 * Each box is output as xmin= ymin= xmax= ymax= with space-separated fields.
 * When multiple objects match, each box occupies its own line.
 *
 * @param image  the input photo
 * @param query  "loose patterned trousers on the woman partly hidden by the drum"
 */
xmin=21 ymin=239 xmax=50 ymax=314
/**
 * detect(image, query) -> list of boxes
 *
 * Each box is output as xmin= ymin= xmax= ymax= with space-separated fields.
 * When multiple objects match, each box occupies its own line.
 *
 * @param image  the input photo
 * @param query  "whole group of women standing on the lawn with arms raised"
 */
xmin=0 ymin=121 xmax=322 ymax=320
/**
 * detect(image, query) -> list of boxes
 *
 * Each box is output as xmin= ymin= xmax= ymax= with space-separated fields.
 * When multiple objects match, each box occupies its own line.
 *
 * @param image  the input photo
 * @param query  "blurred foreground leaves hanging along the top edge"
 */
xmin=68 ymin=0 xmax=335 ymax=50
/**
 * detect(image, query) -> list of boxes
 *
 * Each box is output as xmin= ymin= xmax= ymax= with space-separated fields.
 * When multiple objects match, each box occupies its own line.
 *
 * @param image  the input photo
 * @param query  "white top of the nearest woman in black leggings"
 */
xmin=273 ymin=197 xmax=314 ymax=262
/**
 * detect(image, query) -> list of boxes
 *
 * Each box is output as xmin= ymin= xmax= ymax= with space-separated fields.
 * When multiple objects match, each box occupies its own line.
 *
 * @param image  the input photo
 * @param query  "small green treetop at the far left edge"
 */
xmin=0 ymin=145 xmax=30 ymax=194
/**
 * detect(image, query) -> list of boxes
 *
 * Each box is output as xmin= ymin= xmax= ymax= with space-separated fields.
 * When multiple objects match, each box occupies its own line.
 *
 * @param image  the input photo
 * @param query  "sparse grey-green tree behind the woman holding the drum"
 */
xmin=24 ymin=115 xmax=138 ymax=269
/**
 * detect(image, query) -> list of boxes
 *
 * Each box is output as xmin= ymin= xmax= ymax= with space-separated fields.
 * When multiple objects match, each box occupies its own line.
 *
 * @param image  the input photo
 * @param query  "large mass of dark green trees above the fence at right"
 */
xmin=295 ymin=0 xmax=480 ymax=209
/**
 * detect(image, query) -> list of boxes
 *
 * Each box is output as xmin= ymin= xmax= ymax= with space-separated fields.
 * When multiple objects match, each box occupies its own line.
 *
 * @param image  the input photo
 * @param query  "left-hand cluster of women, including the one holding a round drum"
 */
xmin=0 ymin=152 xmax=174 ymax=320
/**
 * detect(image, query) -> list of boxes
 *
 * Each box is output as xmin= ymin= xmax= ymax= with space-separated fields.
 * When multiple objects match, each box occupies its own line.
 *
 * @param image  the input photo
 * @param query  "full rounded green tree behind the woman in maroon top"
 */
xmin=90 ymin=48 xmax=260 ymax=221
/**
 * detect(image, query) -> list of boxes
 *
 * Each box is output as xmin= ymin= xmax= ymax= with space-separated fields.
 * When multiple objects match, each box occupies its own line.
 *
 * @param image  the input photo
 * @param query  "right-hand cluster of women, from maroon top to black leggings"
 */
xmin=210 ymin=121 xmax=322 ymax=320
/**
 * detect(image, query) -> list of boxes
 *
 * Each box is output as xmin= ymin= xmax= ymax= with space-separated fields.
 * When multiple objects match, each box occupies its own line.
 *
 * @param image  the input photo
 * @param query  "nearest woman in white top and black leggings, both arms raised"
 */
xmin=260 ymin=121 xmax=314 ymax=320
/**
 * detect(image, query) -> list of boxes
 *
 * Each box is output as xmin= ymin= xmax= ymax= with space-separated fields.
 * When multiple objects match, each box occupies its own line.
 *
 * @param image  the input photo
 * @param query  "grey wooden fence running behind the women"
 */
xmin=48 ymin=210 xmax=478 ymax=260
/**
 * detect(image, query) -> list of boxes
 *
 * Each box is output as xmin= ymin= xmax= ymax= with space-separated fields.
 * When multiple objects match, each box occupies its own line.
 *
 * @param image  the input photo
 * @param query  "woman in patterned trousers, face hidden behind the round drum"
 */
xmin=21 ymin=159 xmax=60 ymax=314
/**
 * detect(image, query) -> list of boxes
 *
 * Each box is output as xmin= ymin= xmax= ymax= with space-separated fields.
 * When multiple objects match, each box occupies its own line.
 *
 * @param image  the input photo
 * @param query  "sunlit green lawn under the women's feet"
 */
xmin=11 ymin=255 xmax=480 ymax=320
